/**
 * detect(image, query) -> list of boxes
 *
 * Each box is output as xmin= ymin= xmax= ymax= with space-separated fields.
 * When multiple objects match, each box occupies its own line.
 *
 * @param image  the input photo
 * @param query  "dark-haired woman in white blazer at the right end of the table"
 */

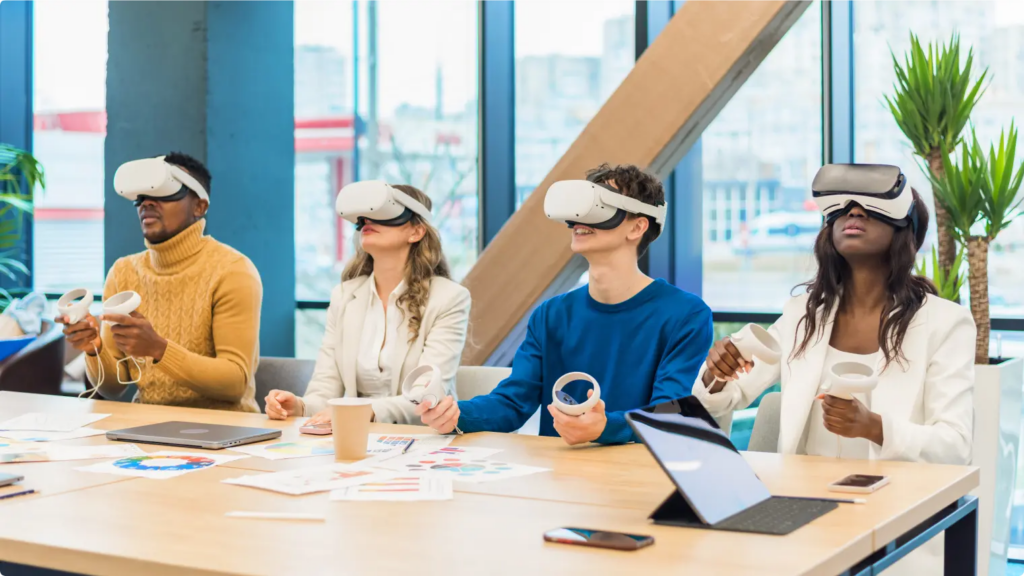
xmin=693 ymin=186 xmax=975 ymax=463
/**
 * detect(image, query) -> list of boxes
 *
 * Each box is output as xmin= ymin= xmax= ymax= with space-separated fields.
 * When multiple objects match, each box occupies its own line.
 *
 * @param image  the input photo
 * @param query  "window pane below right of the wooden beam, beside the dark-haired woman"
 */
xmin=701 ymin=2 xmax=823 ymax=312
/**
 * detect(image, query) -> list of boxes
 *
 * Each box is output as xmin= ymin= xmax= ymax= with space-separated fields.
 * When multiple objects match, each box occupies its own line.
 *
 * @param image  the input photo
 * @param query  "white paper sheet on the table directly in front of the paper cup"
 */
xmin=222 ymin=464 xmax=394 ymax=495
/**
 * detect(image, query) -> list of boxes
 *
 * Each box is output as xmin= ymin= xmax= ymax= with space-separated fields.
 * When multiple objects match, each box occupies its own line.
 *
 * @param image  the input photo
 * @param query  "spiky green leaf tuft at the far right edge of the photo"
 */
xmin=980 ymin=121 xmax=1024 ymax=240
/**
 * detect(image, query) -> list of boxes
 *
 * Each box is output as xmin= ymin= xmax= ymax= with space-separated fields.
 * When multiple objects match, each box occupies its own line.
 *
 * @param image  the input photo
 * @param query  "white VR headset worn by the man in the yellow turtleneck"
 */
xmin=114 ymin=156 xmax=210 ymax=206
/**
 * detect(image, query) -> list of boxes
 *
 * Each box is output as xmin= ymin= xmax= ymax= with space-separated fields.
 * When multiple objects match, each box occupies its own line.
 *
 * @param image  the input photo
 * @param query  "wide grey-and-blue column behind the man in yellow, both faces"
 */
xmin=104 ymin=1 xmax=295 ymax=356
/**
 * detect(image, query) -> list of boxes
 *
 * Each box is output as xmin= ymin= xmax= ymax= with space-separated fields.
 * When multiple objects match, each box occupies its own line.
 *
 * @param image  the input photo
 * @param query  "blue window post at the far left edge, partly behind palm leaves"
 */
xmin=0 ymin=0 xmax=33 ymax=290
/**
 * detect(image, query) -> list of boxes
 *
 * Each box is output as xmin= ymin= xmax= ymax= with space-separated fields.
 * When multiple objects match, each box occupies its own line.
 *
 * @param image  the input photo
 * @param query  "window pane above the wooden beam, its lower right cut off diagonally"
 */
xmin=515 ymin=0 xmax=636 ymax=207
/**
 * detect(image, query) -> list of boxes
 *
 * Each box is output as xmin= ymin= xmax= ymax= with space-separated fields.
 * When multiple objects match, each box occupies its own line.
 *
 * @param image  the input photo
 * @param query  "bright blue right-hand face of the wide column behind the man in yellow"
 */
xmin=206 ymin=1 xmax=295 ymax=356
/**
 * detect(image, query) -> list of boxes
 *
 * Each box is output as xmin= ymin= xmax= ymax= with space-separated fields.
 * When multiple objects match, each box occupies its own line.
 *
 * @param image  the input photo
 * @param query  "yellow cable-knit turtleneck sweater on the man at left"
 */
xmin=86 ymin=219 xmax=263 ymax=412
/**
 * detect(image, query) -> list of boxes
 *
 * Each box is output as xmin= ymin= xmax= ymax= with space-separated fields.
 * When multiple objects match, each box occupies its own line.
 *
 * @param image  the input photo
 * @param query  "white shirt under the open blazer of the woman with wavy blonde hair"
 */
xmin=355 ymin=274 xmax=406 ymax=398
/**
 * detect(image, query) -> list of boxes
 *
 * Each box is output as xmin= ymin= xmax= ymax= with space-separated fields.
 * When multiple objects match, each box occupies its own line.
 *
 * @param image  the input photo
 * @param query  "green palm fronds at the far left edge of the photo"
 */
xmin=0 ymin=143 xmax=46 ymax=310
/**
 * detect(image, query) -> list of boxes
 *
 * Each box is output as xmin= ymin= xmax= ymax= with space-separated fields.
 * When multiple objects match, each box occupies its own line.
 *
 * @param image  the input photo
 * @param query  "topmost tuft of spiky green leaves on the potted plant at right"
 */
xmin=885 ymin=33 xmax=988 ymax=157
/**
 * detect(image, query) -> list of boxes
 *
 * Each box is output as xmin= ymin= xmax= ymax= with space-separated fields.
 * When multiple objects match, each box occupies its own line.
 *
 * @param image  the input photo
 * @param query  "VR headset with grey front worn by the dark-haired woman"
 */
xmin=811 ymin=164 xmax=918 ymax=232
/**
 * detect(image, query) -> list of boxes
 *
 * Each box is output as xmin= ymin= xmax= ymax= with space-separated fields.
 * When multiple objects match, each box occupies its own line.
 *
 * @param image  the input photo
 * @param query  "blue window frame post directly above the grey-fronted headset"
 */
xmin=821 ymin=0 xmax=854 ymax=163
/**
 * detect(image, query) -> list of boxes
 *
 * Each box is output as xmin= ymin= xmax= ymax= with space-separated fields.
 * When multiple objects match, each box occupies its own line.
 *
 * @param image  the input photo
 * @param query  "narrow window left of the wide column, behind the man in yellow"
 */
xmin=33 ymin=0 xmax=108 ymax=293
